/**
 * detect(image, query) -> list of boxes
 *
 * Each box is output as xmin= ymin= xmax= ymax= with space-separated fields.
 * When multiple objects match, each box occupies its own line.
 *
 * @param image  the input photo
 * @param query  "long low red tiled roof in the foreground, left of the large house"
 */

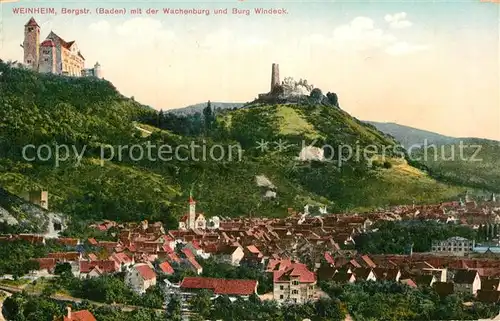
xmin=180 ymin=277 xmax=257 ymax=295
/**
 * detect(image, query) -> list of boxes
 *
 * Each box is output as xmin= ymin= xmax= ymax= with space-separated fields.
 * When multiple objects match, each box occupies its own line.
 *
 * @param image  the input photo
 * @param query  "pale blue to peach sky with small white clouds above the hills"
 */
xmin=0 ymin=0 xmax=500 ymax=139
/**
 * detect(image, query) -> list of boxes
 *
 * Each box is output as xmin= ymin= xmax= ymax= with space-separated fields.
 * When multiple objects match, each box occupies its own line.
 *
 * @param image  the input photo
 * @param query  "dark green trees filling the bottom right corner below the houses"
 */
xmin=321 ymin=281 xmax=500 ymax=321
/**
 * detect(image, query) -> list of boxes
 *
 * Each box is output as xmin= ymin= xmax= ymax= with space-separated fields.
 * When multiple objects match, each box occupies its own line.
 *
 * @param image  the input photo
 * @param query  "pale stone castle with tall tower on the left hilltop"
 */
xmin=21 ymin=17 xmax=102 ymax=78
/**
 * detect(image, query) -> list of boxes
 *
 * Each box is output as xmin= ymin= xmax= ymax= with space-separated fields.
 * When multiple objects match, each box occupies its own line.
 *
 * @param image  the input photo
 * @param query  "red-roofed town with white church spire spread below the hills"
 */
xmin=0 ymin=198 xmax=500 ymax=321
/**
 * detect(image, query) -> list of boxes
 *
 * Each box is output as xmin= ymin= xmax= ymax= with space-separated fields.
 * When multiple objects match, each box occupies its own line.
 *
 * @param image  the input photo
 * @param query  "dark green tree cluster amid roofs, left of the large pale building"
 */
xmin=354 ymin=220 xmax=480 ymax=254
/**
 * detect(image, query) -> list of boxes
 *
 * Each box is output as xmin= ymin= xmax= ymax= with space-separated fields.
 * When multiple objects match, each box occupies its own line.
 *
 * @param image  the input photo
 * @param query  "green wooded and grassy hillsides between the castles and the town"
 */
xmin=0 ymin=63 xmax=463 ymax=228
